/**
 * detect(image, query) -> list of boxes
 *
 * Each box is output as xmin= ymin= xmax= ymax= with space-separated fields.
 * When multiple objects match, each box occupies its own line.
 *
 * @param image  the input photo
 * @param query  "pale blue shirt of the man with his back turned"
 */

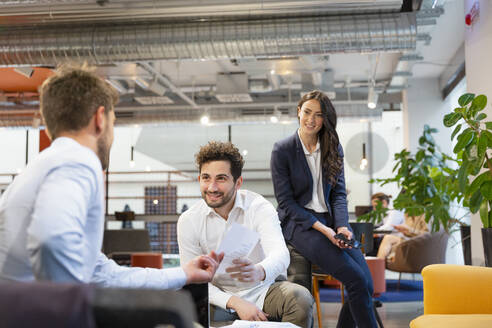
xmin=0 ymin=137 xmax=186 ymax=289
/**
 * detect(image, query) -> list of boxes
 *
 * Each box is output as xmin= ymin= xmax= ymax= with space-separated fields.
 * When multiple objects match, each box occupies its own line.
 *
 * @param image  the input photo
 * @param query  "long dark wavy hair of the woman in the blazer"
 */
xmin=298 ymin=90 xmax=343 ymax=185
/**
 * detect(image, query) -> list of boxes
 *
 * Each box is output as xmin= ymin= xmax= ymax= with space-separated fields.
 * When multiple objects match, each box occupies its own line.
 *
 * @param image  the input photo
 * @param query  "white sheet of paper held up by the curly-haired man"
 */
xmin=216 ymin=223 xmax=260 ymax=275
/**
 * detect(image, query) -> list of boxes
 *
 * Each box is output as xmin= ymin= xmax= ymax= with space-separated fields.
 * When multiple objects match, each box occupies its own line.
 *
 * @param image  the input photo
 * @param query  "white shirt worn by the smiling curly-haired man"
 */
xmin=178 ymin=190 xmax=290 ymax=309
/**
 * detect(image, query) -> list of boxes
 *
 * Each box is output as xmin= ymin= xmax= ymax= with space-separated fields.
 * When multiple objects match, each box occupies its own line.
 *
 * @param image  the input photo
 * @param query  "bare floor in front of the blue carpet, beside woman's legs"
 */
xmin=314 ymin=302 xmax=424 ymax=328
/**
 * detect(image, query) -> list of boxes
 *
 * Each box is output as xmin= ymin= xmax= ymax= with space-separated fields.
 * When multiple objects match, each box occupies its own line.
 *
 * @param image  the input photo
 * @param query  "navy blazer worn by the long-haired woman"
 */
xmin=270 ymin=131 xmax=350 ymax=241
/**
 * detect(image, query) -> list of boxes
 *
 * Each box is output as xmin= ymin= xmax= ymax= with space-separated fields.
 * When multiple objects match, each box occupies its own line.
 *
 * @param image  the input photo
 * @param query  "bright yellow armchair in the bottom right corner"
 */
xmin=410 ymin=264 xmax=492 ymax=328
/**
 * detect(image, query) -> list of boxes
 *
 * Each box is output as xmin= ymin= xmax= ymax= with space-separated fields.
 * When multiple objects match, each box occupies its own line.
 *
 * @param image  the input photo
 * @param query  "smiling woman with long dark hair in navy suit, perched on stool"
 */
xmin=271 ymin=91 xmax=377 ymax=327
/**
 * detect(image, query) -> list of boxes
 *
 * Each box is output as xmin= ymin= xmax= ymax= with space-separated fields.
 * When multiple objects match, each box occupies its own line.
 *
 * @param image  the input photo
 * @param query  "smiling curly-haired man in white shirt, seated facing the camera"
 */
xmin=178 ymin=142 xmax=313 ymax=327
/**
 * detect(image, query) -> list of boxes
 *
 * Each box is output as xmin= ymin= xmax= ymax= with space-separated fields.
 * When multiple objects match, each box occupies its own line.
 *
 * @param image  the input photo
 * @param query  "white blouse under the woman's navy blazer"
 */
xmin=297 ymin=130 xmax=328 ymax=213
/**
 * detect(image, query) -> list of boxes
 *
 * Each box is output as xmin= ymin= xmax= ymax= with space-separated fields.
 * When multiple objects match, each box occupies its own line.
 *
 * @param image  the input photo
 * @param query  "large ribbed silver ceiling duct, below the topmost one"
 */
xmin=0 ymin=13 xmax=417 ymax=66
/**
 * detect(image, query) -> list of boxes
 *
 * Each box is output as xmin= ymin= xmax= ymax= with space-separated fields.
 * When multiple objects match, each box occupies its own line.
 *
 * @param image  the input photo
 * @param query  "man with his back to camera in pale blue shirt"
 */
xmin=0 ymin=66 xmax=223 ymax=289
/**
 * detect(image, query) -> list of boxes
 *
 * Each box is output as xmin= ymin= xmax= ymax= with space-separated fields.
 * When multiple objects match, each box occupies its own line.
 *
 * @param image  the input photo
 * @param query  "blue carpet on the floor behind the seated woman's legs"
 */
xmin=319 ymin=280 xmax=424 ymax=303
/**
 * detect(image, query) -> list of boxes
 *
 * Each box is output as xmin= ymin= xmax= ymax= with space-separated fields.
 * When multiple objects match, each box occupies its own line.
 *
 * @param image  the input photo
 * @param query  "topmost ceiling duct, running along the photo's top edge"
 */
xmin=0 ymin=0 xmax=403 ymax=24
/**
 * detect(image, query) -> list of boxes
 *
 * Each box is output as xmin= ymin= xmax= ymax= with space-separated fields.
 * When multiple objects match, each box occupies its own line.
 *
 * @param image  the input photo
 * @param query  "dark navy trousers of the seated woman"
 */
xmin=289 ymin=212 xmax=377 ymax=328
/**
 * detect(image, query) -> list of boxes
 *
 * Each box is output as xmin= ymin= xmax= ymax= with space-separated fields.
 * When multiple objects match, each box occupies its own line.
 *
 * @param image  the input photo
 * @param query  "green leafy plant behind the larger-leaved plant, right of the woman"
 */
xmin=358 ymin=125 xmax=465 ymax=232
